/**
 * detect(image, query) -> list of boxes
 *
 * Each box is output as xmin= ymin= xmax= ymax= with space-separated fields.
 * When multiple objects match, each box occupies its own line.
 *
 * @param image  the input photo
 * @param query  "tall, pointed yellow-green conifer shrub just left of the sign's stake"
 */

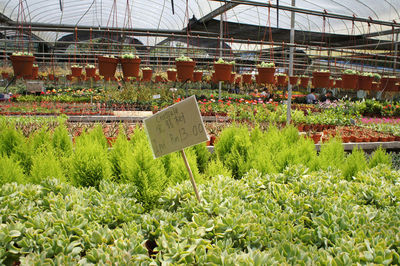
xmin=120 ymin=130 xmax=168 ymax=209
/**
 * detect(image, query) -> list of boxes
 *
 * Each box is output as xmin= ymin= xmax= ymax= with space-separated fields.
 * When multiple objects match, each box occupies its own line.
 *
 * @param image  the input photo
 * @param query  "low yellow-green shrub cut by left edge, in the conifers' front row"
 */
xmin=0 ymin=155 xmax=25 ymax=186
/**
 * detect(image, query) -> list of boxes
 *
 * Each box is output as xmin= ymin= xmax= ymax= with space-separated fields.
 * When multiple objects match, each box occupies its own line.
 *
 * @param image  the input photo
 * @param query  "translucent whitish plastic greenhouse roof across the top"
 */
xmin=0 ymin=0 xmax=400 ymax=45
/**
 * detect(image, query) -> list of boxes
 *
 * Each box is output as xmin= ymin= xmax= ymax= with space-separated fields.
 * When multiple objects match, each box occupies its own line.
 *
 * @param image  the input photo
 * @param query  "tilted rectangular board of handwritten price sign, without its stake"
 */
xmin=144 ymin=96 xmax=208 ymax=158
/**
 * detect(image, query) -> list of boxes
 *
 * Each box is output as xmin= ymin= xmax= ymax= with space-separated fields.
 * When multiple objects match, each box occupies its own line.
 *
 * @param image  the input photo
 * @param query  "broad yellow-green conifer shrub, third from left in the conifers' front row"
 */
xmin=70 ymin=132 xmax=111 ymax=187
